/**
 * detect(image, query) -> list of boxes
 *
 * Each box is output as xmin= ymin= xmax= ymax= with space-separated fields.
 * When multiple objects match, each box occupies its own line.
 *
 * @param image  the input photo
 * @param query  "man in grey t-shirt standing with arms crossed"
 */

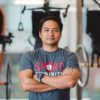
xmin=19 ymin=16 xmax=80 ymax=100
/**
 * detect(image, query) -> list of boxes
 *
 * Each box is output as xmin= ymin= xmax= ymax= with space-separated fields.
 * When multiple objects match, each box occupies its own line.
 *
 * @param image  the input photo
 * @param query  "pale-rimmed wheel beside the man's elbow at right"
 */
xmin=76 ymin=45 xmax=89 ymax=87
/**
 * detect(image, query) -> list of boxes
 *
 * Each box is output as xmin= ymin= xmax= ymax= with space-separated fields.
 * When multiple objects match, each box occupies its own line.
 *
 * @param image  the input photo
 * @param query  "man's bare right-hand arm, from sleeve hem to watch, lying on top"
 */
xmin=42 ymin=69 xmax=80 ymax=89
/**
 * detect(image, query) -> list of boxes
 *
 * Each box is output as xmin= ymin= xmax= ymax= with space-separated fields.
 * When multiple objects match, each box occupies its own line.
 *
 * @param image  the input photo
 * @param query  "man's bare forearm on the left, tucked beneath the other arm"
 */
xmin=22 ymin=78 xmax=55 ymax=92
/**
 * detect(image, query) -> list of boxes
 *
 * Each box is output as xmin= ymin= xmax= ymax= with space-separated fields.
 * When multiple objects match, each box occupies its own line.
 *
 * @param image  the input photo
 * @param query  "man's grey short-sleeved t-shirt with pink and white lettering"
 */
xmin=20 ymin=48 xmax=79 ymax=100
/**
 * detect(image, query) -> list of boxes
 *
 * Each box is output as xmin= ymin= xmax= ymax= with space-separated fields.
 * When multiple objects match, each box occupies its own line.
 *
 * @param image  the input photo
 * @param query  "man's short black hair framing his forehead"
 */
xmin=38 ymin=16 xmax=63 ymax=32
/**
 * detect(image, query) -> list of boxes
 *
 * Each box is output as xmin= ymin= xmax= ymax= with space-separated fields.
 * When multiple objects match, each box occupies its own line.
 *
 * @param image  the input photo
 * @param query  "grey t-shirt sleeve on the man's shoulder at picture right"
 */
xmin=66 ymin=53 xmax=79 ymax=69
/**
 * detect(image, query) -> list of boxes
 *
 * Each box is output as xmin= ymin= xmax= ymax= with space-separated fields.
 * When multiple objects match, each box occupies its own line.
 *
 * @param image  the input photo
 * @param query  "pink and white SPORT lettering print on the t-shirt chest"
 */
xmin=34 ymin=62 xmax=63 ymax=76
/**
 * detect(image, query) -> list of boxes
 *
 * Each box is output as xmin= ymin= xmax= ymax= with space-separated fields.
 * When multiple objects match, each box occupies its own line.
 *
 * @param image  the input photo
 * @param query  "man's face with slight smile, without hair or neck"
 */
xmin=39 ymin=20 xmax=61 ymax=45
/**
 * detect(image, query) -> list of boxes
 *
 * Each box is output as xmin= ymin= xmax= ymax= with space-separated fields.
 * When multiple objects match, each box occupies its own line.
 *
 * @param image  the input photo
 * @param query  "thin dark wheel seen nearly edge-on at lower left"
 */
xmin=6 ymin=62 xmax=12 ymax=100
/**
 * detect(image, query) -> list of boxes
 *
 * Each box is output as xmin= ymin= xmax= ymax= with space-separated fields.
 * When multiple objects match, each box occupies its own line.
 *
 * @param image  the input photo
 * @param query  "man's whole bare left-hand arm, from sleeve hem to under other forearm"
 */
xmin=19 ymin=69 xmax=55 ymax=92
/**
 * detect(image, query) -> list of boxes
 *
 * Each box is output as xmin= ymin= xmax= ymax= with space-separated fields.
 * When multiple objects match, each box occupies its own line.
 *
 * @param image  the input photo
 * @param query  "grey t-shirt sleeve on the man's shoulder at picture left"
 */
xmin=20 ymin=53 xmax=32 ymax=70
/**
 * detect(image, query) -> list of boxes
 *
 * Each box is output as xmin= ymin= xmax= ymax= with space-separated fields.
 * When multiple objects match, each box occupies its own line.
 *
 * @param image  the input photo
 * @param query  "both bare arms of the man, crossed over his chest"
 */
xmin=19 ymin=69 xmax=80 ymax=92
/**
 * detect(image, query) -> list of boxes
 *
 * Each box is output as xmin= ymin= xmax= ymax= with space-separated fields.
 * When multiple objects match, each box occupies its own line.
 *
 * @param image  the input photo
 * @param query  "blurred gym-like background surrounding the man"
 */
xmin=0 ymin=0 xmax=100 ymax=100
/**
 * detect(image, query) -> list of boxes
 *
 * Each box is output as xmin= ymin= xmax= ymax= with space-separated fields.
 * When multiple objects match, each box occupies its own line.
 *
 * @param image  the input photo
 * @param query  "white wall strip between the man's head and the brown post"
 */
xmin=60 ymin=7 xmax=77 ymax=51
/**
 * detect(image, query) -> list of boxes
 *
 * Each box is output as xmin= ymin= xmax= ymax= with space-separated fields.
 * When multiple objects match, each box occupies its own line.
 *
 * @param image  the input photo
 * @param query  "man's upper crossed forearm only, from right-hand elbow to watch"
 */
xmin=42 ymin=75 xmax=75 ymax=89
